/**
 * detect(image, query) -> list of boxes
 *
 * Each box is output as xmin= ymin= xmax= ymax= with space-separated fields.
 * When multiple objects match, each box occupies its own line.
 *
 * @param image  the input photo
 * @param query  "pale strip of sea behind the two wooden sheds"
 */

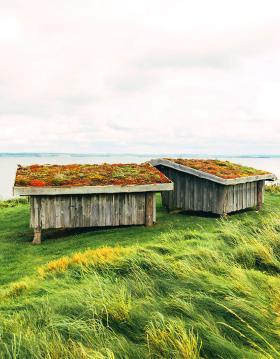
xmin=0 ymin=153 xmax=280 ymax=200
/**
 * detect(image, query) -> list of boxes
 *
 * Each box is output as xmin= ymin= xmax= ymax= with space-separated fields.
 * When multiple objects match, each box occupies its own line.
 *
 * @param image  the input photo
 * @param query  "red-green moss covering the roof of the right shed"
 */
xmin=166 ymin=158 xmax=270 ymax=179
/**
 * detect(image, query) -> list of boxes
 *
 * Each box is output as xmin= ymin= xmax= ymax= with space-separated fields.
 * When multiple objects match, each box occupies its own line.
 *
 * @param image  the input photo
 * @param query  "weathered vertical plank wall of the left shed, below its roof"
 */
xmin=30 ymin=192 xmax=156 ymax=229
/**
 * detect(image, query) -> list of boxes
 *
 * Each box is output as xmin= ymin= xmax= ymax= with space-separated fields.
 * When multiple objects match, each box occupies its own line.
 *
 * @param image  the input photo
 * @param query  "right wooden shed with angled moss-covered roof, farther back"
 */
xmin=150 ymin=158 xmax=276 ymax=215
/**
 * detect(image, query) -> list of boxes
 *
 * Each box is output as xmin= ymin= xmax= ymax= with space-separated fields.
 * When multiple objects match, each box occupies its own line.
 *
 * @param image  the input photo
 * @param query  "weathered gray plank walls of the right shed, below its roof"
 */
xmin=158 ymin=165 xmax=258 ymax=214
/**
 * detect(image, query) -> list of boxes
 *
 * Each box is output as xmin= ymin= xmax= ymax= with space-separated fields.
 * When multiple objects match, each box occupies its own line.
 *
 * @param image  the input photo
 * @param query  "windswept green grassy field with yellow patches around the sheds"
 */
xmin=0 ymin=190 xmax=280 ymax=359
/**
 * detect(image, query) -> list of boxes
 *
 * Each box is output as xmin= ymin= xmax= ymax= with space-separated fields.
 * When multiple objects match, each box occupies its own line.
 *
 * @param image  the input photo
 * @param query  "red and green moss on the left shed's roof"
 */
xmin=15 ymin=163 xmax=171 ymax=187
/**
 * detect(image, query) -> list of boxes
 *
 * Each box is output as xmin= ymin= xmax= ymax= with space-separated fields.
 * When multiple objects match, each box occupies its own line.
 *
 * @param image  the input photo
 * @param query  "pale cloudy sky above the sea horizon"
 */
xmin=0 ymin=0 xmax=280 ymax=154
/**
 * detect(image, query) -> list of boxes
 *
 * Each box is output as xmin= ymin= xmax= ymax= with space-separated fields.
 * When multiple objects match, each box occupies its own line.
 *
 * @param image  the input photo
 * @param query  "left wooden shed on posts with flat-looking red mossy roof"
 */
xmin=14 ymin=163 xmax=173 ymax=243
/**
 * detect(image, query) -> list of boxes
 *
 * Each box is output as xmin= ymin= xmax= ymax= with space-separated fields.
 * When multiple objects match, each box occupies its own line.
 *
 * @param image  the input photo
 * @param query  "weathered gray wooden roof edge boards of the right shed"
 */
xmin=149 ymin=158 xmax=277 ymax=186
